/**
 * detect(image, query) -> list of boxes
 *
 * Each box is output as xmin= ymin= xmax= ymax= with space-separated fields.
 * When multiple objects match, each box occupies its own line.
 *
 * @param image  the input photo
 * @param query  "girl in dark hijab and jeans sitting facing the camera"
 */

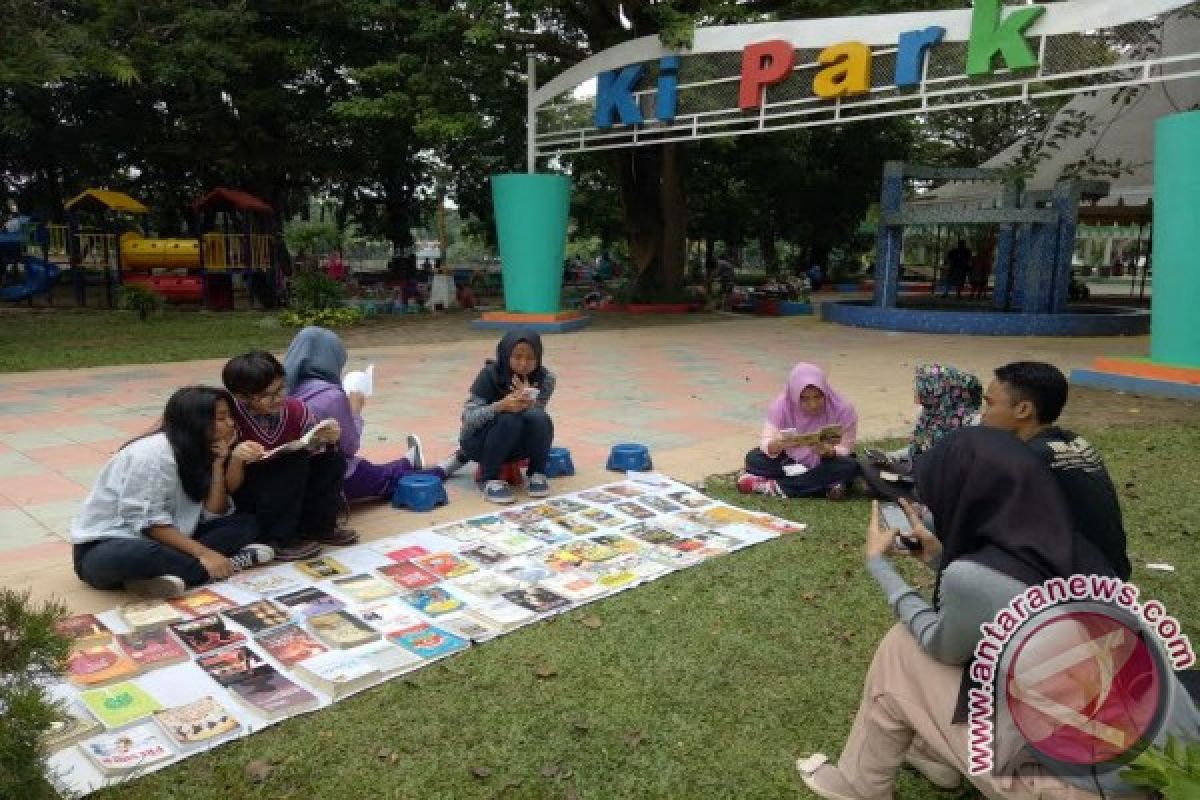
xmin=458 ymin=327 xmax=554 ymax=503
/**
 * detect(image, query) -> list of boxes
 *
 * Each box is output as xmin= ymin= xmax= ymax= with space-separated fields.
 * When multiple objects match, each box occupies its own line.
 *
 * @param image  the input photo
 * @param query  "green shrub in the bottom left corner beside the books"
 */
xmin=0 ymin=589 xmax=67 ymax=800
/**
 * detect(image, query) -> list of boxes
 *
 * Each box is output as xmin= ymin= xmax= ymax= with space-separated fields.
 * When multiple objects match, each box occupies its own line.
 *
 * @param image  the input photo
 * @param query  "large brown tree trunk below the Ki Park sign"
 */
xmin=613 ymin=144 xmax=688 ymax=300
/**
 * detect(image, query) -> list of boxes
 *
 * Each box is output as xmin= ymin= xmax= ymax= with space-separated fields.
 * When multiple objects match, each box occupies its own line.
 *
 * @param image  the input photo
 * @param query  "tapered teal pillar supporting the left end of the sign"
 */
xmin=492 ymin=173 xmax=571 ymax=314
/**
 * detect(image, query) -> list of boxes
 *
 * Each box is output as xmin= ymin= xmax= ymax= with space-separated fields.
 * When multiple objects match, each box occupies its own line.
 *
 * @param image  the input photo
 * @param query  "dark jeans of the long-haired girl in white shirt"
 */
xmin=73 ymin=513 xmax=258 ymax=589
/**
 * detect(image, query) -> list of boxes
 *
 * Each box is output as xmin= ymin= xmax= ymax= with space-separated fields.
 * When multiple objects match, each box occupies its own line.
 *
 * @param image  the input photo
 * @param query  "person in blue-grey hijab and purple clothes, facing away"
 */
xmin=283 ymin=325 xmax=446 ymax=501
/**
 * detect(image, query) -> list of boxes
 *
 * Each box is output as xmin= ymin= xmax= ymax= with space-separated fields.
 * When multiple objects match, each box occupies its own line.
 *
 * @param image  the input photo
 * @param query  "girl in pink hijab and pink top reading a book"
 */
xmin=738 ymin=362 xmax=858 ymax=500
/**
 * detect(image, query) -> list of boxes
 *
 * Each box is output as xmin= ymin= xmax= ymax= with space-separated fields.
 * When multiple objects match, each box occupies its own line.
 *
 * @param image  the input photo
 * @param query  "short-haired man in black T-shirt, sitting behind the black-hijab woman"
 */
xmin=983 ymin=361 xmax=1132 ymax=579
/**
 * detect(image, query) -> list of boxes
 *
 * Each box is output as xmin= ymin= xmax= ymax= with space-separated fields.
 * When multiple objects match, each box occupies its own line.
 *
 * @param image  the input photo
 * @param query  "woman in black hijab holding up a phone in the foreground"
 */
xmin=797 ymin=427 xmax=1200 ymax=800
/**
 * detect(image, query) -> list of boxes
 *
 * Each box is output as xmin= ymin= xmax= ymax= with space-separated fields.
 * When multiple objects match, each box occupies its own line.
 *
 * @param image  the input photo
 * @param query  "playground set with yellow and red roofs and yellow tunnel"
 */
xmin=36 ymin=188 xmax=278 ymax=311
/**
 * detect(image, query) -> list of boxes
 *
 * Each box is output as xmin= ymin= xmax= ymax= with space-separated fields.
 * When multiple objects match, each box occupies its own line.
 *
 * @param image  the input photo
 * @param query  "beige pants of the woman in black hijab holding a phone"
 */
xmin=838 ymin=624 xmax=1140 ymax=800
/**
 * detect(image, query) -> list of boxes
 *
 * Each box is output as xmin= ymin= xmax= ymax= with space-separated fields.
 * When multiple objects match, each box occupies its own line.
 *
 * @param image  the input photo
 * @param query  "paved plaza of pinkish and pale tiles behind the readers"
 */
xmin=0 ymin=317 xmax=1148 ymax=612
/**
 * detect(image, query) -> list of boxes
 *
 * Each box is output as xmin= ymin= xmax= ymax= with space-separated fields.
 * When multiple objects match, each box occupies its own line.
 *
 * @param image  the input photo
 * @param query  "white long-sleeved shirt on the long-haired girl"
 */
xmin=71 ymin=433 xmax=225 ymax=545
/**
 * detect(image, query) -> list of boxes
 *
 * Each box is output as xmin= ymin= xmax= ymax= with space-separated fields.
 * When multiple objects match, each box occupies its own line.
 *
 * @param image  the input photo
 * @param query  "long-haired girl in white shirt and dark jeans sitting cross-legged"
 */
xmin=71 ymin=386 xmax=275 ymax=597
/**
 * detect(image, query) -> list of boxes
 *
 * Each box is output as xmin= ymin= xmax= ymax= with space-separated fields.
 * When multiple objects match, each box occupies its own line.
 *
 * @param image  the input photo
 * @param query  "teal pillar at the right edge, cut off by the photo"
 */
xmin=1150 ymin=112 xmax=1200 ymax=367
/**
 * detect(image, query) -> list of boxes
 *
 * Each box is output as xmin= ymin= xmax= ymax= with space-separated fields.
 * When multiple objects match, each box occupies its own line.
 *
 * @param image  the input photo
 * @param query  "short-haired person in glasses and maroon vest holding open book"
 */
xmin=221 ymin=350 xmax=359 ymax=561
